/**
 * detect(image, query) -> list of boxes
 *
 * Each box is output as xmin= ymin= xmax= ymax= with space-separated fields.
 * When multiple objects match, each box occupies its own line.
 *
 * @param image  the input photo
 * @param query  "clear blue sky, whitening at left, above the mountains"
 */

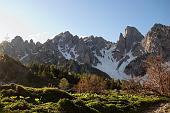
xmin=0 ymin=0 xmax=170 ymax=42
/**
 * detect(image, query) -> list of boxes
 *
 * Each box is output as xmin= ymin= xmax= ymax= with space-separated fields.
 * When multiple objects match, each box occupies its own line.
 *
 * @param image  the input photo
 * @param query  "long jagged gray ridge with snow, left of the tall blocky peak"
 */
xmin=0 ymin=29 xmax=144 ymax=78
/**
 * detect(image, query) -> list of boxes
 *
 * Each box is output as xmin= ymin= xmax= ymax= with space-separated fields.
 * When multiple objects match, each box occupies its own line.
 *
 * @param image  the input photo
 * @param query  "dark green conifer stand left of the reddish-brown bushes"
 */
xmin=26 ymin=64 xmax=80 ymax=89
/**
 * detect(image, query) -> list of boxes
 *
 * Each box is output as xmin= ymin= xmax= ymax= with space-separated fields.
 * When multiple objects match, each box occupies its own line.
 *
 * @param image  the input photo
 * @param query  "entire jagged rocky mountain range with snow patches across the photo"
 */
xmin=0 ymin=24 xmax=170 ymax=79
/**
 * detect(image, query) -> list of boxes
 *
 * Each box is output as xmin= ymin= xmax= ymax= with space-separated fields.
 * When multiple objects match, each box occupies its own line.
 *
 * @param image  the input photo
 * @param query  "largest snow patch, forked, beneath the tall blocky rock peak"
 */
xmin=93 ymin=48 xmax=136 ymax=79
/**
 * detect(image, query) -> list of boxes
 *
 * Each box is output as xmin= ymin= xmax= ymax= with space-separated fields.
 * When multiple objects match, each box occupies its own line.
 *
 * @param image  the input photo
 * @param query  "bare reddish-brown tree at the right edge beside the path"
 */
xmin=144 ymin=56 xmax=170 ymax=95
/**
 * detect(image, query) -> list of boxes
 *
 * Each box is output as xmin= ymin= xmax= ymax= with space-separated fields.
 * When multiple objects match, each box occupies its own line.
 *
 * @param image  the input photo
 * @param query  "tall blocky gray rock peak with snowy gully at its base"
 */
xmin=113 ymin=26 xmax=144 ymax=74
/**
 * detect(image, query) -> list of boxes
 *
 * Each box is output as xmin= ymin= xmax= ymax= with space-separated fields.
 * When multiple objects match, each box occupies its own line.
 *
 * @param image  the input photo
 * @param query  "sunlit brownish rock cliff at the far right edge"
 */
xmin=143 ymin=24 xmax=170 ymax=61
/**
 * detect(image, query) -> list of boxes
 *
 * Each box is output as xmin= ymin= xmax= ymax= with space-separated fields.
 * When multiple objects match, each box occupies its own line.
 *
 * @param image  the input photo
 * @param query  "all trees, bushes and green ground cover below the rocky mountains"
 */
xmin=0 ymin=56 xmax=170 ymax=113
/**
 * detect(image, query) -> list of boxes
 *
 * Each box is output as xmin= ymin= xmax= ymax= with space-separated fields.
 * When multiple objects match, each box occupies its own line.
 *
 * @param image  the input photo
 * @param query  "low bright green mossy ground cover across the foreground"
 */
xmin=0 ymin=84 xmax=167 ymax=113
